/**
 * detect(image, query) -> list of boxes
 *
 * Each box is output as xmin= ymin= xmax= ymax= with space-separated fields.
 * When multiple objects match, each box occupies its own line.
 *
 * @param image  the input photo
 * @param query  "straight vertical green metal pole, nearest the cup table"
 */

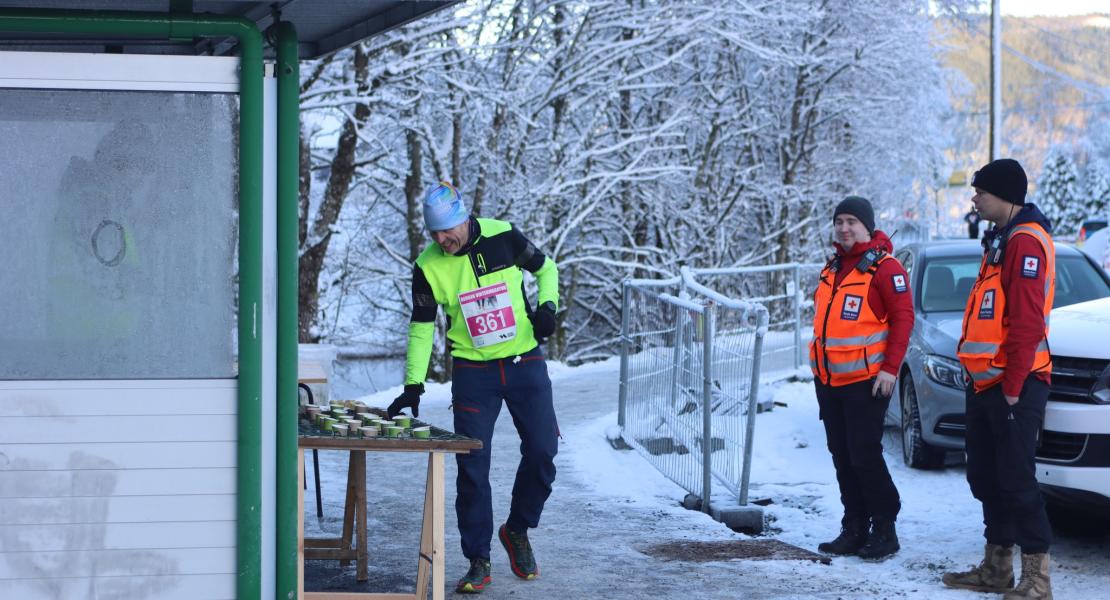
xmin=275 ymin=21 xmax=301 ymax=600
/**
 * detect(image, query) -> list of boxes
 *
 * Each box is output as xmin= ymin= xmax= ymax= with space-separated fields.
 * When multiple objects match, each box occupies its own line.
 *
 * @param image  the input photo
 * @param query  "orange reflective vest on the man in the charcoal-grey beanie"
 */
xmin=809 ymin=254 xmax=896 ymax=386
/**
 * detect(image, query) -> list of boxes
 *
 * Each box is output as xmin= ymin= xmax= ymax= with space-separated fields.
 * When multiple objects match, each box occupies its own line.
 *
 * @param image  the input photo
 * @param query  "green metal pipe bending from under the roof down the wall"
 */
xmin=0 ymin=9 xmax=263 ymax=599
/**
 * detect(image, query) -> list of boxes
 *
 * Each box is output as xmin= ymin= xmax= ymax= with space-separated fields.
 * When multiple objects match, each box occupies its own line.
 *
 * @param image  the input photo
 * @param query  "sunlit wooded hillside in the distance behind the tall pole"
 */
xmin=944 ymin=14 xmax=1110 ymax=179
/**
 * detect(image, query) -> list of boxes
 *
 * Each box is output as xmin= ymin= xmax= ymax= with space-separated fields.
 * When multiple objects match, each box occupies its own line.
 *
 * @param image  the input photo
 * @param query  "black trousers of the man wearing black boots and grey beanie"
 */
xmin=816 ymin=379 xmax=901 ymax=521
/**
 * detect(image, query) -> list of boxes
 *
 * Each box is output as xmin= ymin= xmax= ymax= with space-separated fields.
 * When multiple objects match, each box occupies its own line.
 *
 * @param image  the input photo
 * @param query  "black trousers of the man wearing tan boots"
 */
xmin=967 ymin=376 xmax=1052 ymax=555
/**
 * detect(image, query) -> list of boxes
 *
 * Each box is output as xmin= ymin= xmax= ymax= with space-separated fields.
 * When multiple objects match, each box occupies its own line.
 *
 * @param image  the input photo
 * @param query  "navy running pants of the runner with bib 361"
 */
xmin=451 ymin=347 xmax=558 ymax=559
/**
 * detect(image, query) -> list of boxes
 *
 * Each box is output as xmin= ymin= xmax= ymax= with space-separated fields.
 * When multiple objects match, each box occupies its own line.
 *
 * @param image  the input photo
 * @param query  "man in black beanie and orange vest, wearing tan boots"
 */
xmin=944 ymin=159 xmax=1056 ymax=600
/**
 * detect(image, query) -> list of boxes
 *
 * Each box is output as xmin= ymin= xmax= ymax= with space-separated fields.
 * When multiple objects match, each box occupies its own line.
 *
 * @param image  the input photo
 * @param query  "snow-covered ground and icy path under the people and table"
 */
xmin=305 ymin=360 xmax=1110 ymax=600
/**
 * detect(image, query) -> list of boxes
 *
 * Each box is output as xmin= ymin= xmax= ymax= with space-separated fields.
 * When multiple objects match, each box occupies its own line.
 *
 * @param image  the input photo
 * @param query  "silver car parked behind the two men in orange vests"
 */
xmin=887 ymin=240 xmax=1110 ymax=469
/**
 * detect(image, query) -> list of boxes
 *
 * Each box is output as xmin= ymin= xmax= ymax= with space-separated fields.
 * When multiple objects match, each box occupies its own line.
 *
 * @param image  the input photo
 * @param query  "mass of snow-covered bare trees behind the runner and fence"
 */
xmin=302 ymin=0 xmax=947 ymax=359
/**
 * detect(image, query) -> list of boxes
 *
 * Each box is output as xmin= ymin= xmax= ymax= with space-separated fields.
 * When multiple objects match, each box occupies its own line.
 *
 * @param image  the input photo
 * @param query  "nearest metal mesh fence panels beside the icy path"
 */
xmin=618 ymin=272 xmax=768 ymax=511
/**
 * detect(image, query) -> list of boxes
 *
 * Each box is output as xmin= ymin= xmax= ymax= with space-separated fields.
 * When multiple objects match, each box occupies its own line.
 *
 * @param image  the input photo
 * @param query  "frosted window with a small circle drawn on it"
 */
xmin=0 ymin=89 xmax=239 ymax=379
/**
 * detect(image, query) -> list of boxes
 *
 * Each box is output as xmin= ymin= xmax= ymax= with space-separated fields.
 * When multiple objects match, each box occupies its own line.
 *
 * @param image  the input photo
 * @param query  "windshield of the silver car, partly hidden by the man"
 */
xmin=920 ymin=250 xmax=1110 ymax=313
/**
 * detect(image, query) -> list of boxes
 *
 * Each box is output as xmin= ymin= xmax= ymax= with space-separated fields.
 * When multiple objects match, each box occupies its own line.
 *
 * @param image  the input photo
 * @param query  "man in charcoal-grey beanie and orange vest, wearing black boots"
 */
xmin=809 ymin=196 xmax=914 ymax=560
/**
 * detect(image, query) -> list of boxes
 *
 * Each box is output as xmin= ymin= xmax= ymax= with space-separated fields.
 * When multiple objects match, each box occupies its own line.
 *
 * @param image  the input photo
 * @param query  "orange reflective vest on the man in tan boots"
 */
xmin=956 ymin=223 xmax=1056 ymax=391
